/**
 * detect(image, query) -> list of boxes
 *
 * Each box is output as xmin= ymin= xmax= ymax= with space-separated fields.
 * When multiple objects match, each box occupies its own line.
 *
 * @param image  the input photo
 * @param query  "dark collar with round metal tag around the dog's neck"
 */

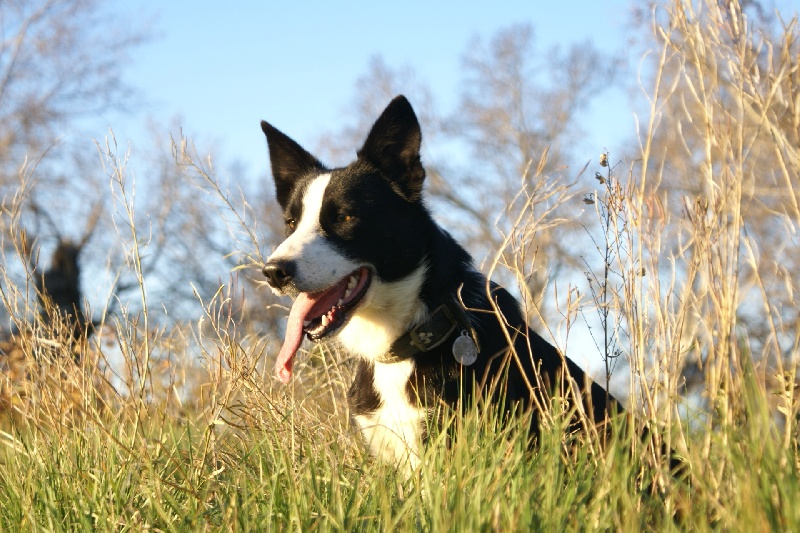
xmin=375 ymin=301 xmax=480 ymax=365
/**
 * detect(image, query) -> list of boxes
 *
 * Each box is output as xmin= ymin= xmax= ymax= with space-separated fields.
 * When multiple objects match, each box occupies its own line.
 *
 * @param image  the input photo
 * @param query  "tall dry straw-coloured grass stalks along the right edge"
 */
xmin=628 ymin=2 xmax=800 ymax=448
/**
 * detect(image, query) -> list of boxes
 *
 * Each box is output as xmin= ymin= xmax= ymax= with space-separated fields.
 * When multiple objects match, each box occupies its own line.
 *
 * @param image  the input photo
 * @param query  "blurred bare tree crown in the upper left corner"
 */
xmin=0 ymin=0 xmax=145 ymax=320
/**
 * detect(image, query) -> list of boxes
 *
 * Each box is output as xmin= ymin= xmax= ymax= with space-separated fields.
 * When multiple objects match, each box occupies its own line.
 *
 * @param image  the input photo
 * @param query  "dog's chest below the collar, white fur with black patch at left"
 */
xmin=350 ymin=361 xmax=426 ymax=469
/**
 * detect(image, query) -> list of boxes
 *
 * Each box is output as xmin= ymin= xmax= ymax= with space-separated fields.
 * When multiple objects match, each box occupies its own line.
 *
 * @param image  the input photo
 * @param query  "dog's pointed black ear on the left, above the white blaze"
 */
xmin=261 ymin=120 xmax=326 ymax=208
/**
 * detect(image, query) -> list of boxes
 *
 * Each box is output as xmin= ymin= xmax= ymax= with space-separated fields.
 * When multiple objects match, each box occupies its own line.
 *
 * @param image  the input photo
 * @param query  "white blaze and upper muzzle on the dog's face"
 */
xmin=268 ymin=174 xmax=360 ymax=292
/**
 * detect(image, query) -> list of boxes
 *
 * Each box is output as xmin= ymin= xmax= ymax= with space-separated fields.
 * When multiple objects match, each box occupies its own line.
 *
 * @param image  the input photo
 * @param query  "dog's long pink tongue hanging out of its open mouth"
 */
xmin=275 ymin=278 xmax=349 ymax=383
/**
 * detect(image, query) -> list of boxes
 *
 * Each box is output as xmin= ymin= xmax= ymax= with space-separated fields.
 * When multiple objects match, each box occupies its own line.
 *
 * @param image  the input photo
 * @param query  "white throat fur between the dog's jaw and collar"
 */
xmin=338 ymin=265 xmax=427 ymax=360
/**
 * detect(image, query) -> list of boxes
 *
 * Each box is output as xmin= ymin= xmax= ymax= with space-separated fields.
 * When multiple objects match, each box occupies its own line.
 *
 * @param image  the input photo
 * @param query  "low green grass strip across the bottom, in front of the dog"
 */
xmin=0 ymin=360 xmax=800 ymax=531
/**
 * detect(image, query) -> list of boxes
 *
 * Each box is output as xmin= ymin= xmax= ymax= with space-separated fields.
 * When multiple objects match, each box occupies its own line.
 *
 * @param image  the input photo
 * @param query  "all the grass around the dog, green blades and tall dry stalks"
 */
xmin=0 ymin=2 xmax=800 ymax=531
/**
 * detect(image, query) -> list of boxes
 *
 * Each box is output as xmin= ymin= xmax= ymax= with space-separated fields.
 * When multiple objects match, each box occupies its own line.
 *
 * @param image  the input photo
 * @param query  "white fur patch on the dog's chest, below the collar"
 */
xmin=355 ymin=360 xmax=426 ymax=471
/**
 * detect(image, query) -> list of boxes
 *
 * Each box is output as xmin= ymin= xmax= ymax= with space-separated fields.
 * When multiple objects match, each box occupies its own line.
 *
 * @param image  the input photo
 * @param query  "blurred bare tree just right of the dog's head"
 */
xmin=447 ymin=25 xmax=614 ymax=313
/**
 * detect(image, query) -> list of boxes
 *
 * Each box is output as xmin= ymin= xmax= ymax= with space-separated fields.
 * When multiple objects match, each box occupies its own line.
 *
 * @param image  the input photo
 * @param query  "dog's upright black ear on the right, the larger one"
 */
xmin=358 ymin=95 xmax=425 ymax=201
